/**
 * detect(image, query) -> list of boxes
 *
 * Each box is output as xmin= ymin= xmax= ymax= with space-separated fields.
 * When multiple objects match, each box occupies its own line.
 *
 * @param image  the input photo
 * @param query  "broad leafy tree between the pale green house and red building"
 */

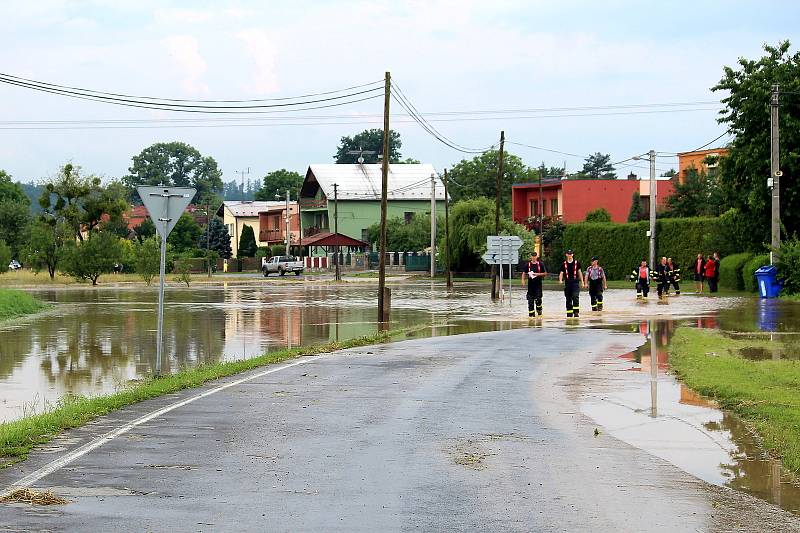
xmin=448 ymin=150 xmax=539 ymax=212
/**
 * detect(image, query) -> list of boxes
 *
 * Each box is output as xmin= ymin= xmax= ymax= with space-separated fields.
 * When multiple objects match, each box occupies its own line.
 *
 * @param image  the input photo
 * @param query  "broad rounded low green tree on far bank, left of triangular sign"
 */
xmin=62 ymin=232 xmax=122 ymax=285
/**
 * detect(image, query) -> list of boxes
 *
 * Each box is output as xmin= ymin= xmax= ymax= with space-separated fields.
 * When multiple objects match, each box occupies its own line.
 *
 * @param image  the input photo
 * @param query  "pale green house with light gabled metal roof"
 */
xmin=300 ymin=163 xmax=444 ymax=246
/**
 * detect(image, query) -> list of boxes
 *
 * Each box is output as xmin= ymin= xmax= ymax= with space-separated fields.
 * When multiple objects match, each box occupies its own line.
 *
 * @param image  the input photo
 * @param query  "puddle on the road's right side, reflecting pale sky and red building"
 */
xmin=581 ymin=318 xmax=800 ymax=514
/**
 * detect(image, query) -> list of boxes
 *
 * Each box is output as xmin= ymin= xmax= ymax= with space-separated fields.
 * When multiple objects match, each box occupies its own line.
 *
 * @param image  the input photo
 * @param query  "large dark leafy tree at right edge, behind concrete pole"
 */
xmin=712 ymin=41 xmax=800 ymax=247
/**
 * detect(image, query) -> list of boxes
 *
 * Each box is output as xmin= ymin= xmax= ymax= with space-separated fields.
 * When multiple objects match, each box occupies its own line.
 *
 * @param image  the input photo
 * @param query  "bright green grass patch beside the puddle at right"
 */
xmin=669 ymin=328 xmax=800 ymax=474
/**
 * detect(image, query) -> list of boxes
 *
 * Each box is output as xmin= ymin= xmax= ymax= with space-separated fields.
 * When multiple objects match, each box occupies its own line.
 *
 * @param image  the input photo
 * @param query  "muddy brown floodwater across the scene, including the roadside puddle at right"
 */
xmin=0 ymin=280 xmax=800 ymax=510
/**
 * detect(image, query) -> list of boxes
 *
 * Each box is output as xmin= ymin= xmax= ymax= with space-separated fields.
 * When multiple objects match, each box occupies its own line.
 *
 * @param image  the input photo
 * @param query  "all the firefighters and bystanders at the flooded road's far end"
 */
xmin=521 ymin=250 xmax=719 ymax=318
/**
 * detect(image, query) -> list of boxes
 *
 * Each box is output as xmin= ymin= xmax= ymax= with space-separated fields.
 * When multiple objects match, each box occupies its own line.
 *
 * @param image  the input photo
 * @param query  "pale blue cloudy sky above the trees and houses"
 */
xmin=0 ymin=0 xmax=800 ymax=182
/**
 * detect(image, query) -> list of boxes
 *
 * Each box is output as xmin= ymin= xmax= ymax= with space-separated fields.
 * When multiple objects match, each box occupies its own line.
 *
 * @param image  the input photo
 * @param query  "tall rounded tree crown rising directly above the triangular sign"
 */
xmin=122 ymin=141 xmax=222 ymax=203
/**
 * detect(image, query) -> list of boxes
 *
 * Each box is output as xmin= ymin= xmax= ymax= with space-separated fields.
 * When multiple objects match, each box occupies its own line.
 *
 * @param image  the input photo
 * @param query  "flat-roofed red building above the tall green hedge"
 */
xmin=511 ymin=179 xmax=674 ymax=224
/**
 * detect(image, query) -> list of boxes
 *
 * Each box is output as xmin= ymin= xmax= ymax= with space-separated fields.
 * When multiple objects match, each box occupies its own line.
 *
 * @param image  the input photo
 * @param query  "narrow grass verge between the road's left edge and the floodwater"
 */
xmin=0 ymin=329 xmax=411 ymax=468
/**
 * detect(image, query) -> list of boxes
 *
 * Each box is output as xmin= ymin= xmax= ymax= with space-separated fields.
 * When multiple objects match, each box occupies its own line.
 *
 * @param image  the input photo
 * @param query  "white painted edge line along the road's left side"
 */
xmin=0 ymin=356 xmax=319 ymax=496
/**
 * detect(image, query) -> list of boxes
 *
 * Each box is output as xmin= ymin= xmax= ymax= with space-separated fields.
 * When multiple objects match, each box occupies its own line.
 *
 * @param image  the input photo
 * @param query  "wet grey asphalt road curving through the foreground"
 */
xmin=0 ymin=329 xmax=798 ymax=531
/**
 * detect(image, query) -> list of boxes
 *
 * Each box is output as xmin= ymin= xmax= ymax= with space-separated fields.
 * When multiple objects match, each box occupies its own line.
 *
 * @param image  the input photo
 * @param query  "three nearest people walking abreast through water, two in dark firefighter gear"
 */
xmin=521 ymin=250 xmax=608 ymax=318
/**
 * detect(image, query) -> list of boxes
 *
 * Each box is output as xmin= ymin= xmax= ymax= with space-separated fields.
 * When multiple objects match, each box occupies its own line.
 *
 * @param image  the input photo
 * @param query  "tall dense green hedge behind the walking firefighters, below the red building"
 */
xmin=563 ymin=217 xmax=725 ymax=279
